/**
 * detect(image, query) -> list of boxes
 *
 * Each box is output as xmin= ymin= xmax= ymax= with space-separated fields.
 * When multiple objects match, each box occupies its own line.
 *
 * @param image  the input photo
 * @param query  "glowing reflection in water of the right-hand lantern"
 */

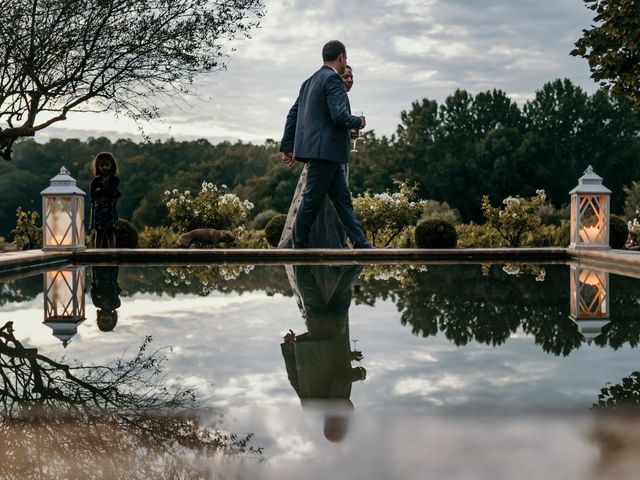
xmin=570 ymin=265 xmax=609 ymax=341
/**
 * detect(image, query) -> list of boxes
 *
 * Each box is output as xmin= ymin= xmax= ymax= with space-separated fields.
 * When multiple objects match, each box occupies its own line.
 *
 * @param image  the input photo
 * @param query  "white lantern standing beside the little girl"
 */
xmin=40 ymin=167 xmax=86 ymax=251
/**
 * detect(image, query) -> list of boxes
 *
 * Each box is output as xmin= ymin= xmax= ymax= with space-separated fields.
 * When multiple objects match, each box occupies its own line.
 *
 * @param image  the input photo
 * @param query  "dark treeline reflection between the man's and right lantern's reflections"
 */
xmin=356 ymin=265 xmax=596 ymax=355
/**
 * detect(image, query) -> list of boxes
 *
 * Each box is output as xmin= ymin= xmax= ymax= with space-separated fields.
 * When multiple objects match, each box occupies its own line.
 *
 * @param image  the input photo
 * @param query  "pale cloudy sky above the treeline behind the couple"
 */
xmin=38 ymin=0 xmax=595 ymax=143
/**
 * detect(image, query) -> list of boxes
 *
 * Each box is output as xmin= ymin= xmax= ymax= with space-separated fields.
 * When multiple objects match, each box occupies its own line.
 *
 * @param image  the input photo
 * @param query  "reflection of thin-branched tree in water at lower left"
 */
xmin=0 ymin=322 xmax=261 ymax=479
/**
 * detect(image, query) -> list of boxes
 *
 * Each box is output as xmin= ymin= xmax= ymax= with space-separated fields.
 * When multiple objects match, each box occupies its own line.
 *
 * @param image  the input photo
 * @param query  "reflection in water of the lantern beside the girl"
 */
xmin=44 ymin=267 xmax=85 ymax=347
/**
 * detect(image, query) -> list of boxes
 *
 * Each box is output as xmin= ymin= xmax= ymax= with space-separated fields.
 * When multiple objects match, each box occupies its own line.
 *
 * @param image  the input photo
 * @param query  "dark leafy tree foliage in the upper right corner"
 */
xmin=571 ymin=0 xmax=640 ymax=106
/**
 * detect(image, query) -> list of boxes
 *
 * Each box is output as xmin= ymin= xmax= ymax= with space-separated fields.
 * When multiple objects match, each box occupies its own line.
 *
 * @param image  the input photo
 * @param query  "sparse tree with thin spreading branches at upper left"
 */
xmin=0 ymin=0 xmax=263 ymax=160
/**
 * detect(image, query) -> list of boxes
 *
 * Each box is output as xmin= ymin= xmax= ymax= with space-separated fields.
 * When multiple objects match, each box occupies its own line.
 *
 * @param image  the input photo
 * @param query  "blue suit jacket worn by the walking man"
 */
xmin=280 ymin=65 xmax=360 ymax=163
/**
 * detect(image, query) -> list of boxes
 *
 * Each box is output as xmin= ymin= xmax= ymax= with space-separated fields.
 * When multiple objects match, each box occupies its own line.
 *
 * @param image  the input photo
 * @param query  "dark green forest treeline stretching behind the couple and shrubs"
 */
xmin=0 ymin=79 xmax=640 ymax=237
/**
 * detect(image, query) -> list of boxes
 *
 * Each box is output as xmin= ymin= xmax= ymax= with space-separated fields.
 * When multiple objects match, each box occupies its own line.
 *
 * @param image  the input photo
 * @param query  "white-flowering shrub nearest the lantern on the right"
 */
xmin=482 ymin=190 xmax=546 ymax=247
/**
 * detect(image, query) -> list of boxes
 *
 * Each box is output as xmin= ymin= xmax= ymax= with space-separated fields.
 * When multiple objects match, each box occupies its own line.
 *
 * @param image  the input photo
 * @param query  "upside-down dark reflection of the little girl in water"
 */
xmin=91 ymin=266 xmax=122 ymax=332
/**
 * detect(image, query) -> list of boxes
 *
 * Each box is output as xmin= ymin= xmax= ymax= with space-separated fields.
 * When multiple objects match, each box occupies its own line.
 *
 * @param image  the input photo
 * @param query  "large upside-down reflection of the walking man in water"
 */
xmin=281 ymin=265 xmax=367 ymax=442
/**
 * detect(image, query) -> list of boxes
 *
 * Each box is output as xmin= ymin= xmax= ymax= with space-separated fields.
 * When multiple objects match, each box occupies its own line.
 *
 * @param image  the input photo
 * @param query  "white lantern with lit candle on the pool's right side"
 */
xmin=569 ymin=165 xmax=611 ymax=249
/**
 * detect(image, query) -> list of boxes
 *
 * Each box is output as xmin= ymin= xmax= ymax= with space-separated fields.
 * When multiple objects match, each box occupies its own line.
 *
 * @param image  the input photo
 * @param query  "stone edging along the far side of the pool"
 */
xmin=0 ymin=247 xmax=640 ymax=279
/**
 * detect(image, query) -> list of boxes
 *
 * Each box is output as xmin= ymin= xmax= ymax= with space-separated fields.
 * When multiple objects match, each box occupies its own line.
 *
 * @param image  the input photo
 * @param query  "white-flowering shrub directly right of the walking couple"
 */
xmin=353 ymin=182 xmax=427 ymax=247
